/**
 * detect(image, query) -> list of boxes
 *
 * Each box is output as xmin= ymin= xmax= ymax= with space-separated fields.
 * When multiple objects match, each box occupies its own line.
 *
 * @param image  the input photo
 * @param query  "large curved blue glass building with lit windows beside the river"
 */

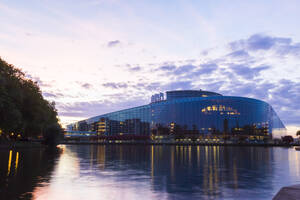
xmin=67 ymin=90 xmax=286 ymax=139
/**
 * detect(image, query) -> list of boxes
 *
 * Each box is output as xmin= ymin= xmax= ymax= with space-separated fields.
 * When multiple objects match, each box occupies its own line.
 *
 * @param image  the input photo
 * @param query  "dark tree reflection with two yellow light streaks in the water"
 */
xmin=0 ymin=149 xmax=60 ymax=199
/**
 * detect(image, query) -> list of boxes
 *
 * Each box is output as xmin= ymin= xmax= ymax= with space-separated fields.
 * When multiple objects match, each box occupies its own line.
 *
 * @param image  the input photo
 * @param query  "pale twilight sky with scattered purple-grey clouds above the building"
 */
xmin=0 ymin=0 xmax=300 ymax=135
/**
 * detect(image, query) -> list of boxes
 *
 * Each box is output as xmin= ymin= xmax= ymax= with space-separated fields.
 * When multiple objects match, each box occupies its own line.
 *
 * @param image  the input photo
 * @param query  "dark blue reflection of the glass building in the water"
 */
xmin=69 ymin=145 xmax=280 ymax=198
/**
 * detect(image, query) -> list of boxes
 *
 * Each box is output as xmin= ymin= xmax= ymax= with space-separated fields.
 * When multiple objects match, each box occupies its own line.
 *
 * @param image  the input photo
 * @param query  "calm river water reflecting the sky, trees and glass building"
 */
xmin=0 ymin=145 xmax=300 ymax=200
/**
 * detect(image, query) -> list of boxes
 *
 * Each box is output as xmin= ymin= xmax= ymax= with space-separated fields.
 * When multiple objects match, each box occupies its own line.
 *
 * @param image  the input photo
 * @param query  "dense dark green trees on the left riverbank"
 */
xmin=0 ymin=58 xmax=61 ymax=143
